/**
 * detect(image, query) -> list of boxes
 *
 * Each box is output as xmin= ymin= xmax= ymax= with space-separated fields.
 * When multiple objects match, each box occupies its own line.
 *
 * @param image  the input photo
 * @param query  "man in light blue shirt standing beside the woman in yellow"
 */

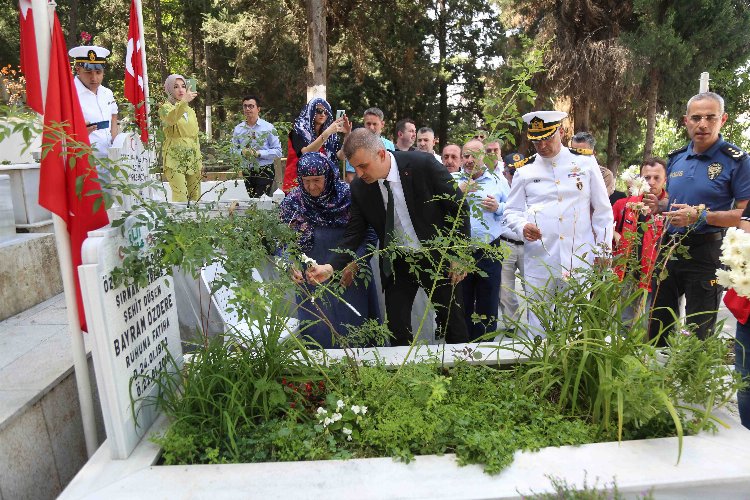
xmin=232 ymin=95 xmax=281 ymax=198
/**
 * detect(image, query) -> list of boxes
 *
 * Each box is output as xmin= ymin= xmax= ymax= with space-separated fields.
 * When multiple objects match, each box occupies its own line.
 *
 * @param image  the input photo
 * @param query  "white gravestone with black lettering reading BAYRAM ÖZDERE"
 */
xmin=78 ymin=217 xmax=183 ymax=459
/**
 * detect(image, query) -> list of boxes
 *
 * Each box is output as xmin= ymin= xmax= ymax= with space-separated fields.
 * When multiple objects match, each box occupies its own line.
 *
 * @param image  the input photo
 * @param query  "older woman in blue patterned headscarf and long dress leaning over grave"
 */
xmin=281 ymin=152 xmax=379 ymax=349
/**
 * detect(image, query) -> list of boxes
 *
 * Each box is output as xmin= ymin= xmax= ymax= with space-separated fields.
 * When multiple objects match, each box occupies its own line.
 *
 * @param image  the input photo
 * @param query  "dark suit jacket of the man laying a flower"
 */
xmin=331 ymin=151 xmax=471 ymax=276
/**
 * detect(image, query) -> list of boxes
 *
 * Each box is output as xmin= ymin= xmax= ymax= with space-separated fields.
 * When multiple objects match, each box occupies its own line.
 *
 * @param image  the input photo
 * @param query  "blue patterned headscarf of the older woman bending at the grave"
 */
xmin=281 ymin=152 xmax=351 ymax=252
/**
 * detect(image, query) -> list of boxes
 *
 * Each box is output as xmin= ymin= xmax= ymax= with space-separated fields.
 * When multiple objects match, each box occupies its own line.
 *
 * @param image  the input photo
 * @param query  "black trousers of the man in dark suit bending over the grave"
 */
xmin=384 ymin=257 xmax=468 ymax=346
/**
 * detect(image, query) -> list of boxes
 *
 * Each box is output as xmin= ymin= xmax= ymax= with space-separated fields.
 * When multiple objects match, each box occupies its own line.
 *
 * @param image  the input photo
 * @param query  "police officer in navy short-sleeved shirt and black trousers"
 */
xmin=644 ymin=92 xmax=750 ymax=345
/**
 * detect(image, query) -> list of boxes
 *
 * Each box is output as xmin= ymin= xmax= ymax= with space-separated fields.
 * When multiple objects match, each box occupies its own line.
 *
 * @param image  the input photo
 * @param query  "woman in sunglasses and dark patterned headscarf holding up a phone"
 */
xmin=282 ymin=97 xmax=352 ymax=193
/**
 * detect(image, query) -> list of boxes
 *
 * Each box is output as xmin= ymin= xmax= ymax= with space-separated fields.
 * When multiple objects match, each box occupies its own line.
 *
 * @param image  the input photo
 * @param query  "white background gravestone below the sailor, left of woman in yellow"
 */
xmin=109 ymin=132 xmax=154 ymax=210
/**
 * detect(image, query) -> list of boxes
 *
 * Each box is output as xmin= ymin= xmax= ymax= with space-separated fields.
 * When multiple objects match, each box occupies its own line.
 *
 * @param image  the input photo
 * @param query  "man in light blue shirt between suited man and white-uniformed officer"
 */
xmin=458 ymin=139 xmax=510 ymax=342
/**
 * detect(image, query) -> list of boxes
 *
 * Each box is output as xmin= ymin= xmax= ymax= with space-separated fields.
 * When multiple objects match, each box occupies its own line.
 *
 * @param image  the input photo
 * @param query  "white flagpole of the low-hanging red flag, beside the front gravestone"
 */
xmin=37 ymin=0 xmax=99 ymax=458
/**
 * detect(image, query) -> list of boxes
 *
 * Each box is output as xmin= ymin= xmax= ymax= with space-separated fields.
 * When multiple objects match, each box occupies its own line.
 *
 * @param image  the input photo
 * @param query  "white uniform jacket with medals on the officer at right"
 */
xmin=505 ymin=146 xmax=614 ymax=278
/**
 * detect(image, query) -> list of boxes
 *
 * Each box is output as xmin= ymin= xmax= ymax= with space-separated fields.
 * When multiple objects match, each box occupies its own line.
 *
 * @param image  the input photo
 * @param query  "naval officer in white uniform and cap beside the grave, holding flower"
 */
xmin=505 ymin=111 xmax=614 ymax=337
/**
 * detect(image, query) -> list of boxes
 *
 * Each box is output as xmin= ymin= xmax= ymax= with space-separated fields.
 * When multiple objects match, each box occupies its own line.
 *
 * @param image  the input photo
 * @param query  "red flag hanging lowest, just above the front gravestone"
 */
xmin=39 ymin=13 xmax=109 ymax=331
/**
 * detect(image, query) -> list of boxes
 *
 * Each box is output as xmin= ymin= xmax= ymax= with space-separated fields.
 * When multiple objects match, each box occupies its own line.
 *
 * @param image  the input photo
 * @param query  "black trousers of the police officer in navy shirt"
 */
xmin=649 ymin=240 xmax=724 ymax=346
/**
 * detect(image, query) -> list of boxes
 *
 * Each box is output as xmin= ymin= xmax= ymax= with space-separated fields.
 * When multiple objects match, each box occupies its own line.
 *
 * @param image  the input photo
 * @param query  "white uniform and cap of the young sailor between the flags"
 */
xmin=68 ymin=45 xmax=118 ymax=158
